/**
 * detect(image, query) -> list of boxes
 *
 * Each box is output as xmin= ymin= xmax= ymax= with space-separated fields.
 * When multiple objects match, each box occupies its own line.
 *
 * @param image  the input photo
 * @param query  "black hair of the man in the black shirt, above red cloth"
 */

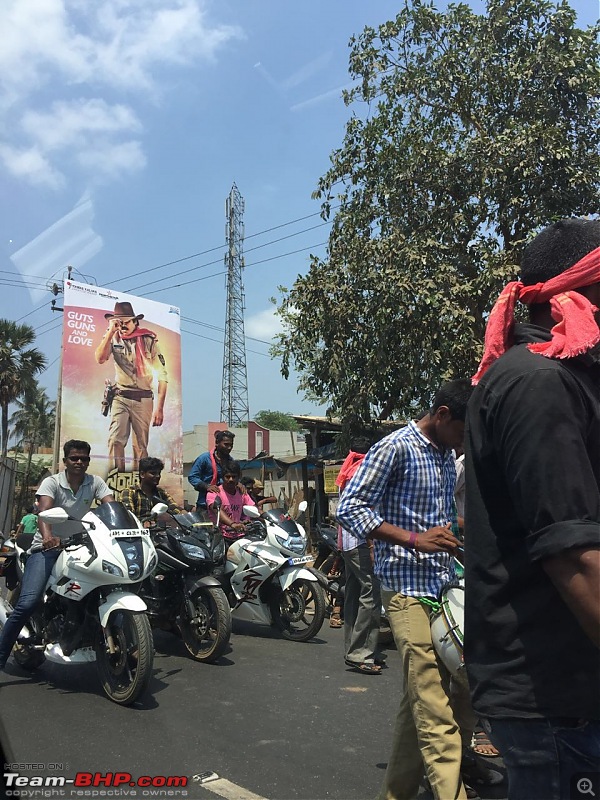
xmin=521 ymin=217 xmax=600 ymax=286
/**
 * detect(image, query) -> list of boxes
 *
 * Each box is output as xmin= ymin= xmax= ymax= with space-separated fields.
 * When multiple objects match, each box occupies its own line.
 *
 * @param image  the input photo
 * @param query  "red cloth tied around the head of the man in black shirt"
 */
xmin=472 ymin=247 xmax=600 ymax=385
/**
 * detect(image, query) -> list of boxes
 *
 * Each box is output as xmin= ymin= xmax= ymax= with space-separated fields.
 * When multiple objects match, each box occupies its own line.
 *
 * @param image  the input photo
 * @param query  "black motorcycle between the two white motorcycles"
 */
xmin=140 ymin=511 xmax=231 ymax=664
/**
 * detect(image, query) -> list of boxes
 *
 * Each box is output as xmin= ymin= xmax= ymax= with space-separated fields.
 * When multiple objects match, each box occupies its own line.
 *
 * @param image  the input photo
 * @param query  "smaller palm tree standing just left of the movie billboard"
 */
xmin=10 ymin=384 xmax=56 ymax=519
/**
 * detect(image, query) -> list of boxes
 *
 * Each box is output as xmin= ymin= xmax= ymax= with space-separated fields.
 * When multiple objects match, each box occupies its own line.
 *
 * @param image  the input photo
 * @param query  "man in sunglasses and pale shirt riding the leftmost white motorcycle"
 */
xmin=0 ymin=439 xmax=114 ymax=670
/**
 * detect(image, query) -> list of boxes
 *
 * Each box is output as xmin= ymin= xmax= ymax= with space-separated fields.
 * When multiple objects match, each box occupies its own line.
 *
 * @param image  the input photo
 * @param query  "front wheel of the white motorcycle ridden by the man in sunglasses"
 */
xmin=95 ymin=609 xmax=154 ymax=706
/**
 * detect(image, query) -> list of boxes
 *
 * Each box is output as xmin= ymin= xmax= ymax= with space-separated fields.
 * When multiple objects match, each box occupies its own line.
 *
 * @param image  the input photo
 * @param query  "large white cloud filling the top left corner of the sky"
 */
xmin=0 ymin=0 xmax=242 ymax=189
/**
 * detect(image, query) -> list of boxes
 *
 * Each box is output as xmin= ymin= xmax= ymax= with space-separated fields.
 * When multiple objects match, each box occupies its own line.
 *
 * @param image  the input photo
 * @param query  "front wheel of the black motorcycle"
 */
xmin=179 ymin=586 xmax=231 ymax=664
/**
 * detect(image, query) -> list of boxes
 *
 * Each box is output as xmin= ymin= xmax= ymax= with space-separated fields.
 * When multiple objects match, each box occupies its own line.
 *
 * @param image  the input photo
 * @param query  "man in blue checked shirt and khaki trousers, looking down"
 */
xmin=337 ymin=380 xmax=475 ymax=800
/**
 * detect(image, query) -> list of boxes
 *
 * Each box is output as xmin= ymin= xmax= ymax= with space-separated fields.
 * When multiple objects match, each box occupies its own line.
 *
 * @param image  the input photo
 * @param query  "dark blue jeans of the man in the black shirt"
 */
xmin=482 ymin=718 xmax=600 ymax=800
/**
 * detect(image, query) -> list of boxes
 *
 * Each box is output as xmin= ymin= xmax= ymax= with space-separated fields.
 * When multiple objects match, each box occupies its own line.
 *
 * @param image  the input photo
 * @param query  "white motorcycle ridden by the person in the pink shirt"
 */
xmin=224 ymin=502 xmax=327 ymax=642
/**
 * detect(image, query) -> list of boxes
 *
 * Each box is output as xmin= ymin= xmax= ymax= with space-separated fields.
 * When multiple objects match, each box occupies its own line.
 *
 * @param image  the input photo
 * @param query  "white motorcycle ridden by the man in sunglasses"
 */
xmin=0 ymin=502 xmax=158 ymax=705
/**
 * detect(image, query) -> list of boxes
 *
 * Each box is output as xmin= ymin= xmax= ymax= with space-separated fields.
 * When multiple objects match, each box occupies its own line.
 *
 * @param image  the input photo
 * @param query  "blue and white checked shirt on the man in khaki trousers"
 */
xmin=336 ymin=422 xmax=456 ymax=599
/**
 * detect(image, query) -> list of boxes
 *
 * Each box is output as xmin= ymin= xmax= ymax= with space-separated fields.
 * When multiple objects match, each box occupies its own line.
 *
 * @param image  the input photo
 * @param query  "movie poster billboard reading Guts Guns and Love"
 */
xmin=59 ymin=280 xmax=183 ymax=504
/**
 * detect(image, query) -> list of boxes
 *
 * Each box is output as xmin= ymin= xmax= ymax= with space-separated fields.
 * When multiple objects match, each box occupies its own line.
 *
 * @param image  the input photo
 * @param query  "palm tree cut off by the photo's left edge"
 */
xmin=0 ymin=319 xmax=46 ymax=457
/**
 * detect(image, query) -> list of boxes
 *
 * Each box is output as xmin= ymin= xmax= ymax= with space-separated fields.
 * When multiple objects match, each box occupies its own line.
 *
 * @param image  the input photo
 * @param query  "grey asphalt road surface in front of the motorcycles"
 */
xmin=0 ymin=620 xmax=506 ymax=800
